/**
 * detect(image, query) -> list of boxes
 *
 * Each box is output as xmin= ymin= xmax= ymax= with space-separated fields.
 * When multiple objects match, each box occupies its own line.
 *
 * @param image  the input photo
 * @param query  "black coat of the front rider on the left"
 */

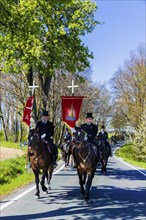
xmin=35 ymin=121 xmax=54 ymax=141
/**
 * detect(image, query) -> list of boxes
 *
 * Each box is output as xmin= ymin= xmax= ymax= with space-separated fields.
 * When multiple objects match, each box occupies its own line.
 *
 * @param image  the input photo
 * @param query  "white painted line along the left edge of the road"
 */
xmin=0 ymin=165 xmax=64 ymax=210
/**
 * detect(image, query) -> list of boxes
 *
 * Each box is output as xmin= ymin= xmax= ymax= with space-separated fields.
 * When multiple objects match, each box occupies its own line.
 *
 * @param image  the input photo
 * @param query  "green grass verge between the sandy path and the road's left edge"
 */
xmin=0 ymin=155 xmax=34 ymax=198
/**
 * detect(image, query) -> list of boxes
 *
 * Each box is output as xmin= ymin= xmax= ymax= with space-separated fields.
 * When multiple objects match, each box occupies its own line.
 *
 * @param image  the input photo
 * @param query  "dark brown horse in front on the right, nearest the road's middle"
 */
xmin=73 ymin=128 xmax=97 ymax=201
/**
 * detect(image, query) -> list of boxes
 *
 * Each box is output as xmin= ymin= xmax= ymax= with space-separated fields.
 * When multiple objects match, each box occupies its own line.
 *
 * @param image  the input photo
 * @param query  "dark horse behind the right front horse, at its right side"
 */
xmin=98 ymin=141 xmax=109 ymax=174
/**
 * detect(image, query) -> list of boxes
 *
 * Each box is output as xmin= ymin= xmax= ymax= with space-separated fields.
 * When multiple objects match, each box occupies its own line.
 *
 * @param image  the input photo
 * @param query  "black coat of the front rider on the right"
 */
xmin=81 ymin=123 xmax=98 ymax=142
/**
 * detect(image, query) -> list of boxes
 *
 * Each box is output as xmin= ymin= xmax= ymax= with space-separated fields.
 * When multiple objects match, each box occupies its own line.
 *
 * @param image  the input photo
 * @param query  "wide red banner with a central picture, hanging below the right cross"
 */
xmin=61 ymin=96 xmax=84 ymax=128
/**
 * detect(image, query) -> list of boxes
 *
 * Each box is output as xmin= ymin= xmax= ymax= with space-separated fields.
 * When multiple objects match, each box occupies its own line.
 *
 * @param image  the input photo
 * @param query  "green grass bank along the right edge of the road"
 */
xmin=115 ymin=144 xmax=146 ymax=169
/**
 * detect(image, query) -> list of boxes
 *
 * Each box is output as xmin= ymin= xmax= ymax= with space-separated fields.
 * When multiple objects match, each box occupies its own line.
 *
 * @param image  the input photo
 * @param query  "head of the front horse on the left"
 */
xmin=28 ymin=129 xmax=41 ymax=148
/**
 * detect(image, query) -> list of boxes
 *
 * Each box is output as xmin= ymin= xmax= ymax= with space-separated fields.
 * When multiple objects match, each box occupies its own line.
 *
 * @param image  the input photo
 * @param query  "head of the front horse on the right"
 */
xmin=73 ymin=127 xmax=87 ymax=147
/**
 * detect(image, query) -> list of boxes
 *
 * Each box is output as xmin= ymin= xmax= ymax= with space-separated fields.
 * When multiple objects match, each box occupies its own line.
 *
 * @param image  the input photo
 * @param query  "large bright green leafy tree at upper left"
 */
xmin=0 ymin=0 xmax=99 ymax=107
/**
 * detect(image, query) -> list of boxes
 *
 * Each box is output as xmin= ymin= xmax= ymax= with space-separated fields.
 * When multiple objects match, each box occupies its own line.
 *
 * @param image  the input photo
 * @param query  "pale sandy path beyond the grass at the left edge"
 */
xmin=0 ymin=147 xmax=24 ymax=160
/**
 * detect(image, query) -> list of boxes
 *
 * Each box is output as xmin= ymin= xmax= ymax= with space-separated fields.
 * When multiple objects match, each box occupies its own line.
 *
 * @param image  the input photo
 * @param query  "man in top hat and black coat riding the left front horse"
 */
xmin=35 ymin=111 xmax=58 ymax=166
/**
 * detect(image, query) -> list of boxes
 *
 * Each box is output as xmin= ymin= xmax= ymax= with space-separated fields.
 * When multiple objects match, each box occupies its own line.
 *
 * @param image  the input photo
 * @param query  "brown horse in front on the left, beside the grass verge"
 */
xmin=28 ymin=129 xmax=53 ymax=198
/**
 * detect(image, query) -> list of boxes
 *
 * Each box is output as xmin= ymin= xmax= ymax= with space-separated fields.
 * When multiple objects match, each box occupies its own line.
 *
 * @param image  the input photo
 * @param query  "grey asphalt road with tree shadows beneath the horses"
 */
xmin=1 ymin=144 xmax=146 ymax=220
